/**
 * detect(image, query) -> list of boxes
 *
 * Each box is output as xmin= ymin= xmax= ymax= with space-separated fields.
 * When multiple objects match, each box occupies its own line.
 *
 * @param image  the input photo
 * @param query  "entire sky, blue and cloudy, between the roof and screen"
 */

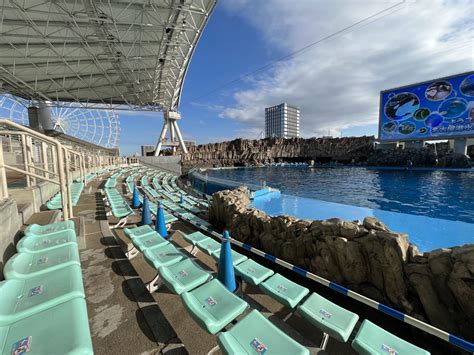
xmin=119 ymin=0 xmax=474 ymax=154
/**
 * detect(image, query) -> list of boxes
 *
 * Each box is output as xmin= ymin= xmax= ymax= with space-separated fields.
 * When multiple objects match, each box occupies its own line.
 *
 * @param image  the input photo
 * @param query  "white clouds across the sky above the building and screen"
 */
xmin=219 ymin=0 xmax=474 ymax=136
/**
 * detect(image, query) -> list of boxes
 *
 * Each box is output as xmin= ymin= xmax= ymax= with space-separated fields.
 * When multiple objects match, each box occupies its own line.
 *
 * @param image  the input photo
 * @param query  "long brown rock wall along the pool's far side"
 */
xmin=182 ymin=136 xmax=469 ymax=173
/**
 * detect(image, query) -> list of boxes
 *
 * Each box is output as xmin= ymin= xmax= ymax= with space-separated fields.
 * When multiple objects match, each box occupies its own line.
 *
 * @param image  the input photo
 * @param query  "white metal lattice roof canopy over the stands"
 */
xmin=0 ymin=0 xmax=216 ymax=111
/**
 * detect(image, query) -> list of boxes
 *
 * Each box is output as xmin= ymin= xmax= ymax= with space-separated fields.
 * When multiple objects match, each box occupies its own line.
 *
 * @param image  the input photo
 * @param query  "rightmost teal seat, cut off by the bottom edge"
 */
xmin=352 ymin=319 xmax=430 ymax=355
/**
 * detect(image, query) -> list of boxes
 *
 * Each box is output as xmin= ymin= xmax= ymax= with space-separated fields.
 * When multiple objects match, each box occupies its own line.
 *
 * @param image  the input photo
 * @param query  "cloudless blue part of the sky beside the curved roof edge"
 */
xmin=119 ymin=1 xmax=279 ymax=154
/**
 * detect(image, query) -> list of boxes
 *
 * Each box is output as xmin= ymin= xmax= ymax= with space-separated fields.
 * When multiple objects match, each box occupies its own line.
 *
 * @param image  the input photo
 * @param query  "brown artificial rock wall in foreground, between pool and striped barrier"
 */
xmin=209 ymin=187 xmax=474 ymax=341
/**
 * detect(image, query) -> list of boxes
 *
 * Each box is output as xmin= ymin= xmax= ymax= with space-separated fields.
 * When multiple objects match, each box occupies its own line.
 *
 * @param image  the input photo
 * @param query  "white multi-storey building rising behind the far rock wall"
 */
xmin=265 ymin=103 xmax=300 ymax=138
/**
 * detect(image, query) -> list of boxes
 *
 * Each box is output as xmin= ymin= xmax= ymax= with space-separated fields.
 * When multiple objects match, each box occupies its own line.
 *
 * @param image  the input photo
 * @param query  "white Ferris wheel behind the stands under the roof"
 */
xmin=0 ymin=94 xmax=120 ymax=148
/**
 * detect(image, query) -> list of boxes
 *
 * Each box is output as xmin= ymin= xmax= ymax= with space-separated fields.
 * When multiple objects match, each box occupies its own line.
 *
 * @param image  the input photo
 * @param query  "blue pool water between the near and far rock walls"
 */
xmin=207 ymin=167 xmax=474 ymax=251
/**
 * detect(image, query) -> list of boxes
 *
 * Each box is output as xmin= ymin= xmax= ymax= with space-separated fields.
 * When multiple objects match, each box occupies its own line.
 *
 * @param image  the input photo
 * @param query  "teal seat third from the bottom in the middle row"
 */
xmin=158 ymin=259 xmax=212 ymax=295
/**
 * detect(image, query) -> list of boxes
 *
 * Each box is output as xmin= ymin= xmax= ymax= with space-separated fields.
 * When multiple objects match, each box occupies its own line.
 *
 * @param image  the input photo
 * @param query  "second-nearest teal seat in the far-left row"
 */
xmin=0 ymin=265 xmax=85 ymax=326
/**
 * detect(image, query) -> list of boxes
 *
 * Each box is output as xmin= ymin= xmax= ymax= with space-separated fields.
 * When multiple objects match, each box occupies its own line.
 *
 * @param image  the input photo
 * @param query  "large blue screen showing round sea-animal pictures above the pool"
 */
xmin=379 ymin=72 xmax=474 ymax=141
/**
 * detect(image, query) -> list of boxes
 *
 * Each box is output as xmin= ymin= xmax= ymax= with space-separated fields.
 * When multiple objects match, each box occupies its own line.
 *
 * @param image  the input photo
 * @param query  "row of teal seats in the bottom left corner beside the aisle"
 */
xmin=0 ymin=221 xmax=93 ymax=354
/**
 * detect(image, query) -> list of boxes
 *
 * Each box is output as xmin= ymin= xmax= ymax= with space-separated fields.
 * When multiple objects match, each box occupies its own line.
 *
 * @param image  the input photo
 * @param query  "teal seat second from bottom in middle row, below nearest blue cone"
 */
xmin=181 ymin=279 xmax=248 ymax=334
